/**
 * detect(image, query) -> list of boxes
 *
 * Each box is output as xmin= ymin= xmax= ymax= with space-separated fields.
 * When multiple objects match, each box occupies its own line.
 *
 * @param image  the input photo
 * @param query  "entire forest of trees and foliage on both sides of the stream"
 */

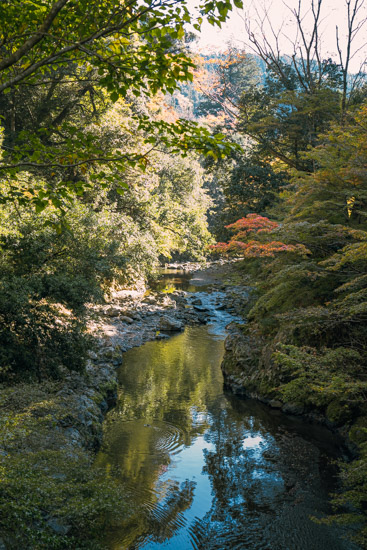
xmin=0 ymin=0 xmax=367 ymax=549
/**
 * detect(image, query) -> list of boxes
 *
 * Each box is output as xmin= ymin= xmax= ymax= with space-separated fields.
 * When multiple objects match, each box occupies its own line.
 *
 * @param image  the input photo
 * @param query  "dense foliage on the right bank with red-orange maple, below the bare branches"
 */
xmin=211 ymin=34 xmax=367 ymax=547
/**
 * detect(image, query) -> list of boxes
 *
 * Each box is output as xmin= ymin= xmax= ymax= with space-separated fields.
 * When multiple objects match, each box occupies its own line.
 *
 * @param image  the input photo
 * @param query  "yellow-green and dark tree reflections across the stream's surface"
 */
xmin=97 ymin=328 xmax=356 ymax=550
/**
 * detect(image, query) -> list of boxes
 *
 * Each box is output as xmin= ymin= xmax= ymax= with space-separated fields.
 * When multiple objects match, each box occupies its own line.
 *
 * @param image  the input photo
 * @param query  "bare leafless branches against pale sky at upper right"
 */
xmin=245 ymin=0 xmax=367 ymax=114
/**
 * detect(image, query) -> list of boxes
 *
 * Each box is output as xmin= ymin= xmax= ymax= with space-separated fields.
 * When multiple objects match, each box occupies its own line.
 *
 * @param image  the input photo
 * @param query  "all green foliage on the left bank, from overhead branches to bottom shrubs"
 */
xmin=0 ymin=0 xmax=241 ymax=550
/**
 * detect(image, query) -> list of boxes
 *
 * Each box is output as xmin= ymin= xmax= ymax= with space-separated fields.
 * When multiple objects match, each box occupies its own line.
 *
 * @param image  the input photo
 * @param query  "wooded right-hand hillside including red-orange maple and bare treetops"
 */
xmin=206 ymin=2 xmax=367 ymax=547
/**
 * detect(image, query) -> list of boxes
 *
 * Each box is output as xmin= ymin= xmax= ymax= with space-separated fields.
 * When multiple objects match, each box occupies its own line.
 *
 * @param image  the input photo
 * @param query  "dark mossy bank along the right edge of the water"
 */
xmin=222 ymin=323 xmax=367 ymax=548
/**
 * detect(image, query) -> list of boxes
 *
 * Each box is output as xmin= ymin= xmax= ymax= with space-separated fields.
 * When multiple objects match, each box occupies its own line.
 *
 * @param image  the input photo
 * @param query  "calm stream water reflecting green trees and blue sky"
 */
xmin=96 ymin=273 xmax=357 ymax=550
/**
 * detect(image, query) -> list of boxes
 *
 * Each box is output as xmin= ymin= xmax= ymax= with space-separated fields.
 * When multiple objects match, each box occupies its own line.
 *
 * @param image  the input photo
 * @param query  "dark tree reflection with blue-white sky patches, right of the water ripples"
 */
xmin=190 ymin=397 xmax=294 ymax=550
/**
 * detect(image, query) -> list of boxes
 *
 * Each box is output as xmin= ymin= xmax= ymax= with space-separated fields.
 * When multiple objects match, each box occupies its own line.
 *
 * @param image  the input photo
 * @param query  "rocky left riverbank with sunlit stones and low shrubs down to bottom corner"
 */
xmin=0 ymin=262 xmax=247 ymax=550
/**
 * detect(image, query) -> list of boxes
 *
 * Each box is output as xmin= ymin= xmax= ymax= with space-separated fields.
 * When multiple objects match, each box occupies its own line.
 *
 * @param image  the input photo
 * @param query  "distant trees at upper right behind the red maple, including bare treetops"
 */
xmin=204 ymin=0 xmax=366 ymax=235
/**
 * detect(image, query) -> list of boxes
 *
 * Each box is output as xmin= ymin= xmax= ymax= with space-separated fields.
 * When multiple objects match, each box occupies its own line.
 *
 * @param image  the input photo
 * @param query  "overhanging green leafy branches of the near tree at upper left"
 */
xmin=0 ymin=0 xmax=243 ymax=209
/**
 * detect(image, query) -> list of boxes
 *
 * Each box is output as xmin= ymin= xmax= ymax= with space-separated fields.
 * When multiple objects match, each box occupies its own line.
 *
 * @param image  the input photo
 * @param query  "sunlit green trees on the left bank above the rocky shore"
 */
xmin=0 ymin=0 xmax=242 ymax=381
